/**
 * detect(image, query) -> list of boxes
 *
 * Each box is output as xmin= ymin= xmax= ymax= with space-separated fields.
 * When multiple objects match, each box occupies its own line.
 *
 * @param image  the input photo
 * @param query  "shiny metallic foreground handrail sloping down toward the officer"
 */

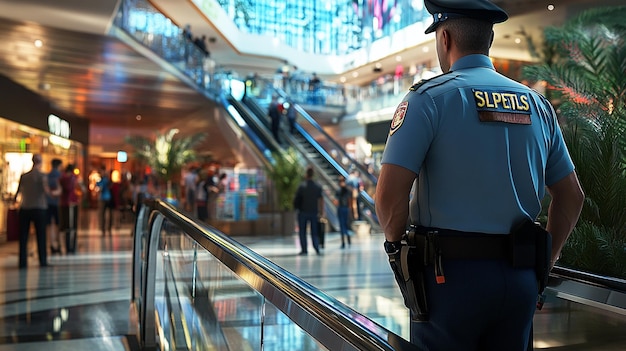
xmin=144 ymin=199 xmax=419 ymax=351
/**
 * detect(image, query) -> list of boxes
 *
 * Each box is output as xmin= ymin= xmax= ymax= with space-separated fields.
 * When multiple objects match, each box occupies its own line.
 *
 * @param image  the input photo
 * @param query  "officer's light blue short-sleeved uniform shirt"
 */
xmin=382 ymin=55 xmax=574 ymax=234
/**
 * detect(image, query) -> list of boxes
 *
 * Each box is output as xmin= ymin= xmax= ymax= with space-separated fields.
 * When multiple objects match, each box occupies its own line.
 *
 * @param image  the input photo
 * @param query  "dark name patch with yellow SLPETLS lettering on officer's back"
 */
xmin=472 ymin=89 xmax=531 ymax=124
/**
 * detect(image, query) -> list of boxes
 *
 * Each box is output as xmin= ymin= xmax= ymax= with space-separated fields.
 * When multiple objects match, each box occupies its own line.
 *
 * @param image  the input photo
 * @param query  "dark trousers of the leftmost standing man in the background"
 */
xmin=19 ymin=209 xmax=48 ymax=268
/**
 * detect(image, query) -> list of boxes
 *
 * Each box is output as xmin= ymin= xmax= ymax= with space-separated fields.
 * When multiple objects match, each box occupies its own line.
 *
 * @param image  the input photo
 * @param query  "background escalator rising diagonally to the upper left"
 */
xmin=111 ymin=1 xmax=380 ymax=231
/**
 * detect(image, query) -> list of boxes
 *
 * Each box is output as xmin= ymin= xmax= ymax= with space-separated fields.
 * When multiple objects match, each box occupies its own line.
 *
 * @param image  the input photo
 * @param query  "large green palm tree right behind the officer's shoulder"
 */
xmin=524 ymin=6 xmax=626 ymax=278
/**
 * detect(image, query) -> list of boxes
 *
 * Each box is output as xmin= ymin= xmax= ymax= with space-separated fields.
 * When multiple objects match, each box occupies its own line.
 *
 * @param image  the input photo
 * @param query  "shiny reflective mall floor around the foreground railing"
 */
xmin=0 ymin=211 xmax=626 ymax=351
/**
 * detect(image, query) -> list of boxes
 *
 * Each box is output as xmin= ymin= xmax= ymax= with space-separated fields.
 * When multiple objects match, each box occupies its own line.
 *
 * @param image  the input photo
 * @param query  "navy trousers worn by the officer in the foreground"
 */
xmin=411 ymin=260 xmax=537 ymax=351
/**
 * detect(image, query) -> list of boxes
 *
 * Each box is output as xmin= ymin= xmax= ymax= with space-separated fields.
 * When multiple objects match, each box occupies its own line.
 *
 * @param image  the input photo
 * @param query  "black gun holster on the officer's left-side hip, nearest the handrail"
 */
xmin=389 ymin=232 xmax=428 ymax=321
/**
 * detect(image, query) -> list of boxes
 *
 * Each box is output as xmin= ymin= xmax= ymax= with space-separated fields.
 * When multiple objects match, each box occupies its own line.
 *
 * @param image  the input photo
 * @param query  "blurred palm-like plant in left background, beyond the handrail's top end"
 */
xmin=126 ymin=128 xmax=205 ymax=203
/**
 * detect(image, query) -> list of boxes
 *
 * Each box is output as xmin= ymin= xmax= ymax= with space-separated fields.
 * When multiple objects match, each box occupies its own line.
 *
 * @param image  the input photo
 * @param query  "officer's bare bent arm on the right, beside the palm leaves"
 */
xmin=546 ymin=171 xmax=585 ymax=265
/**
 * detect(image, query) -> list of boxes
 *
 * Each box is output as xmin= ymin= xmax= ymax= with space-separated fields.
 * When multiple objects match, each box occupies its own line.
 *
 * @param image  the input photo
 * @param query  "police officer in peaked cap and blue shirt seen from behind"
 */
xmin=376 ymin=0 xmax=584 ymax=351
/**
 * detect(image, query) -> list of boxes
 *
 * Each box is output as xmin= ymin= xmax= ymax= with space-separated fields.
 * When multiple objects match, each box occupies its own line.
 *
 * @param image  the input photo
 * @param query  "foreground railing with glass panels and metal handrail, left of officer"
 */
xmin=134 ymin=199 xmax=417 ymax=351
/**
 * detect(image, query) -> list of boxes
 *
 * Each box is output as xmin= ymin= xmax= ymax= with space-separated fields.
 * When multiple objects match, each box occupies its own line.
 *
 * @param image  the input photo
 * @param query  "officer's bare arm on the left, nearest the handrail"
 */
xmin=376 ymin=163 xmax=417 ymax=241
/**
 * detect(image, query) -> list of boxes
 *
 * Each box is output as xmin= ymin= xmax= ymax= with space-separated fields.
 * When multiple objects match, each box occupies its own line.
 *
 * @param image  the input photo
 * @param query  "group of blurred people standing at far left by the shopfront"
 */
xmin=13 ymin=154 xmax=140 ymax=268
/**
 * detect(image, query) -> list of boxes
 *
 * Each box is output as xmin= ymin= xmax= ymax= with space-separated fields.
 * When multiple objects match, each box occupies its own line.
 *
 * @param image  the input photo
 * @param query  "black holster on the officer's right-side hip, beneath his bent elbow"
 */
xmin=509 ymin=220 xmax=552 ymax=294
